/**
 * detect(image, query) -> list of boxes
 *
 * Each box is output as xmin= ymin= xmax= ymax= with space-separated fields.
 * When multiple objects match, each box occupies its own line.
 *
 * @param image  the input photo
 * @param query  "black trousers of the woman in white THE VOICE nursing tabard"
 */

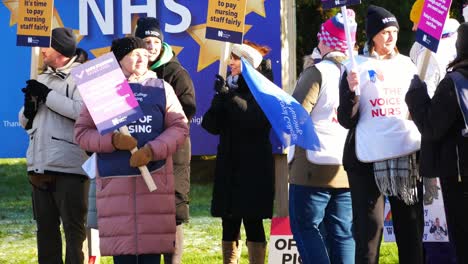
xmin=347 ymin=163 xmax=424 ymax=264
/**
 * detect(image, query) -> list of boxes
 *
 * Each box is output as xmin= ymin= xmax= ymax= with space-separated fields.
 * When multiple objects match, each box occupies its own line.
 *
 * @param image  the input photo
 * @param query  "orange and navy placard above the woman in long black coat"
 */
xmin=205 ymin=0 xmax=247 ymax=43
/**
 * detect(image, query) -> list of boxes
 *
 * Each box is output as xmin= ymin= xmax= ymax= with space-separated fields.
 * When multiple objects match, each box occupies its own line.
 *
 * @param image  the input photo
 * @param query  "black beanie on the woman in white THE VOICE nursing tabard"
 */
xmin=366 ymin=5 xmax=400 ymax=41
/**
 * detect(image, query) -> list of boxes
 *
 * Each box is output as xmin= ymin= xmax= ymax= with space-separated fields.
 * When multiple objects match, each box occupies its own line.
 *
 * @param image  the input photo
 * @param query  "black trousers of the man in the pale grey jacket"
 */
xmin=31 ymin=175 xmax=89 ymax=264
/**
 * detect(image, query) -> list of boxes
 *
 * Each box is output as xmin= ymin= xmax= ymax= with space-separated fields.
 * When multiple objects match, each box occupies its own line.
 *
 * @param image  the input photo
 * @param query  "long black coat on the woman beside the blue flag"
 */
xmin=202 ymin=76 xmax=274 ymax=218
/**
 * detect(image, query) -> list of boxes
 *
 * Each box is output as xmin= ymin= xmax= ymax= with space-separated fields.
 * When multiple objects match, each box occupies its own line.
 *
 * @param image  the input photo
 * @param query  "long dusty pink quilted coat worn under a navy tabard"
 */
xmin=75 ymin=80 xmax=188 ymax=256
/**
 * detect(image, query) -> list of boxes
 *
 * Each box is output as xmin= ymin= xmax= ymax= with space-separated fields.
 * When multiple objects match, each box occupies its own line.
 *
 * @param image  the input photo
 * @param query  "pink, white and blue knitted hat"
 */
xmin=317 ymin=9 xmax=357 ymax=53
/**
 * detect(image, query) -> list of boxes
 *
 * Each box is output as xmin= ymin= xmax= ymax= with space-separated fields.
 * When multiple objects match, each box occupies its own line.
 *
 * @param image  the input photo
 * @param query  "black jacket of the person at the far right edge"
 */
xmin=406 ymin=61 xmax=468 ymax=186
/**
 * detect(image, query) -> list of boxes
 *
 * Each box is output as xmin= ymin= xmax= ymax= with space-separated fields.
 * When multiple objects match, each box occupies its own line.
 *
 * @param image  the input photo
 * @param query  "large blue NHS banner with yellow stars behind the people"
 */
xmin=0 ymin=0 xmax=281 ymax=158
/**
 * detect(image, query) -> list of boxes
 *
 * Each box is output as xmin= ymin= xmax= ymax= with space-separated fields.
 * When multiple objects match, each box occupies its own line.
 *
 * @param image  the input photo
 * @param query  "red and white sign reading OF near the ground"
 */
xmin=268 ymin=217 xmax=302 ymax=264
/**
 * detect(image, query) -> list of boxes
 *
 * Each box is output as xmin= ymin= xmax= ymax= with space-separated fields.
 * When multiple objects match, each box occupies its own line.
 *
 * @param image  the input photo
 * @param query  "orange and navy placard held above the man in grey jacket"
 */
xmin=16 ymin=0 xmax=54 ymax=47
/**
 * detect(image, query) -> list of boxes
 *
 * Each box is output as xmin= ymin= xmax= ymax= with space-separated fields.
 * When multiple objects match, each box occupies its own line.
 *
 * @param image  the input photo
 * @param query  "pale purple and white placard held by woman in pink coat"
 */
xmin=71 ymin=52 xmax=143 ymax=135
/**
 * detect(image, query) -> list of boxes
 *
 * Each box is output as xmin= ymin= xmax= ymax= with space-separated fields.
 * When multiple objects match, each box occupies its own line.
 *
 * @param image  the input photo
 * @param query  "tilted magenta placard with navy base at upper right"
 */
xmin=416 ymin=0 xmax=452 ymax=52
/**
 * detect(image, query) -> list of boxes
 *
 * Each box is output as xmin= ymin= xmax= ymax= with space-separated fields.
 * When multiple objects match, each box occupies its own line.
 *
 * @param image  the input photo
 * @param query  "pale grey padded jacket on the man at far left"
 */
xmin=19 ymin=57 xmax=87 ymax=175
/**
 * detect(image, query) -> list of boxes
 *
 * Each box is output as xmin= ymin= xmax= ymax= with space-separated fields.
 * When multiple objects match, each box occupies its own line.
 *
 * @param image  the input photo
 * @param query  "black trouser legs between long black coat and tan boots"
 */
xmin=222 ymin=217 xmax=266 ymax=242
